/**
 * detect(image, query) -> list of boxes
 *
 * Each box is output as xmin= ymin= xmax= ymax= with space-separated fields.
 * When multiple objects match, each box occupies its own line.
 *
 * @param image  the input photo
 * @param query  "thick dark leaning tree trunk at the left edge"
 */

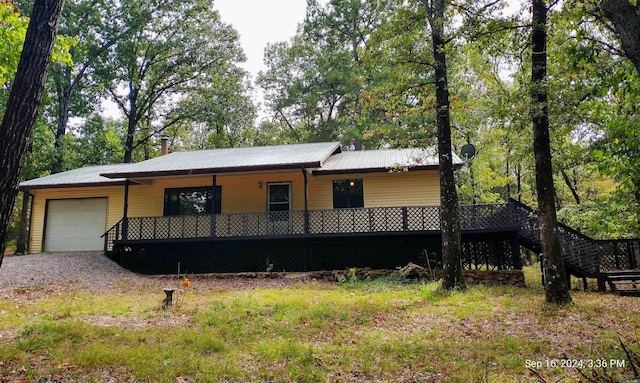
xmin=0 ymin=0 xmax=64 ymax=265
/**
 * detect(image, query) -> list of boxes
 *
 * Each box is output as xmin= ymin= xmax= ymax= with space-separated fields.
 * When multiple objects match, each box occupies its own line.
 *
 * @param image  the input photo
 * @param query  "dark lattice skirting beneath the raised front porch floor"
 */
xmin=111 ymin=232 xmax=522 ymax=274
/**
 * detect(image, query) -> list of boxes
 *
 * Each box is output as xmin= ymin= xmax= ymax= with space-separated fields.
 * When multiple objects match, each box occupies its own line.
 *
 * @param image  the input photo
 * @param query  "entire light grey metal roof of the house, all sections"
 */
xmin=20 ymin=142 xmax=464 ymax=190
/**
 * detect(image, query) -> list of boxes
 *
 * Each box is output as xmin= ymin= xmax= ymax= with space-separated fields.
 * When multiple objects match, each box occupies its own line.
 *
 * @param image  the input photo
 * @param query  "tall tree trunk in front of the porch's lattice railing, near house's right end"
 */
xmin=424 ymin=0 xmax=465 ymax=290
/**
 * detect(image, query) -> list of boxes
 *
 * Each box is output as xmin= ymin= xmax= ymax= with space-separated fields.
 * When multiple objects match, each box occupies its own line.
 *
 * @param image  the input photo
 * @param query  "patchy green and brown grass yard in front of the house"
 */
xmin=0 ymin=269 xmax=640 ymax=382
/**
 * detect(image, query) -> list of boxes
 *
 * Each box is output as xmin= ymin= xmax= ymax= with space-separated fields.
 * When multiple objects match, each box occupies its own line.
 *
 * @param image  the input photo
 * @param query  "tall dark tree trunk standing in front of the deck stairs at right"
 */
xmin=531 ymin=0 xmax=571 ymax=304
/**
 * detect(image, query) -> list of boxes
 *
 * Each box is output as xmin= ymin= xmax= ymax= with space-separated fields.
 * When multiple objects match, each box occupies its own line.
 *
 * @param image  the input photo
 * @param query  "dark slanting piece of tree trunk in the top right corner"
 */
xmin=600 ymin=0 xmax=640 ymax=73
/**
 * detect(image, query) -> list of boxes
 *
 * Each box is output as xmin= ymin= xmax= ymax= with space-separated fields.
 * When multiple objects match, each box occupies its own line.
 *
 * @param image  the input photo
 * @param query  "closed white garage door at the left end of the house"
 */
xmin=44 ymin=198 xmax=107 ymax=251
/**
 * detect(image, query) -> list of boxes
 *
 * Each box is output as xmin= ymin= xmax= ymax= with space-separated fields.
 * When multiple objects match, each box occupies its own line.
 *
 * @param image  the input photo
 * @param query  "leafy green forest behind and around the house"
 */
xmin=0 ymin=0 xmax=640 ymax=249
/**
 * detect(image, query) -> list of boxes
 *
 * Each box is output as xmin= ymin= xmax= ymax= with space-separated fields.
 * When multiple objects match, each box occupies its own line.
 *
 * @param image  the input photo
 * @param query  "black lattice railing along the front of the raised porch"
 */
xmin=105 ymin=204 xmax=518 ymax=252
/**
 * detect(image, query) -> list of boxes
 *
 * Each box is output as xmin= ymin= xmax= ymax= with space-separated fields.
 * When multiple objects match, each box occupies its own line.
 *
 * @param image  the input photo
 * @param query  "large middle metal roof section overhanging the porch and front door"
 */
xmin=102 ymin=142 xmax=340 ymax=178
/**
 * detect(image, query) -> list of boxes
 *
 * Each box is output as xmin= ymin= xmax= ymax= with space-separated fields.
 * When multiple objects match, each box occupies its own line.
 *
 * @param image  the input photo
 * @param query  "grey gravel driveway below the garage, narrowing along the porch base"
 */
xmin=0 ymin=252 xmax=318 ymax=295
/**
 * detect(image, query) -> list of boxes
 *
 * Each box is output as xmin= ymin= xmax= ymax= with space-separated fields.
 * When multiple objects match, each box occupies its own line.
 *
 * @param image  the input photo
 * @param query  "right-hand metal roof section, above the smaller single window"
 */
xmin=312 ymin=148 xmax=464 ymax=174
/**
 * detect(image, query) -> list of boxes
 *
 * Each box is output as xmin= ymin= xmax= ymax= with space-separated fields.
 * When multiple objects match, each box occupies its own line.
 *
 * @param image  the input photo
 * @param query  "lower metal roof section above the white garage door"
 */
xmin=19 ymin=164 xmax=126 ymax=190
